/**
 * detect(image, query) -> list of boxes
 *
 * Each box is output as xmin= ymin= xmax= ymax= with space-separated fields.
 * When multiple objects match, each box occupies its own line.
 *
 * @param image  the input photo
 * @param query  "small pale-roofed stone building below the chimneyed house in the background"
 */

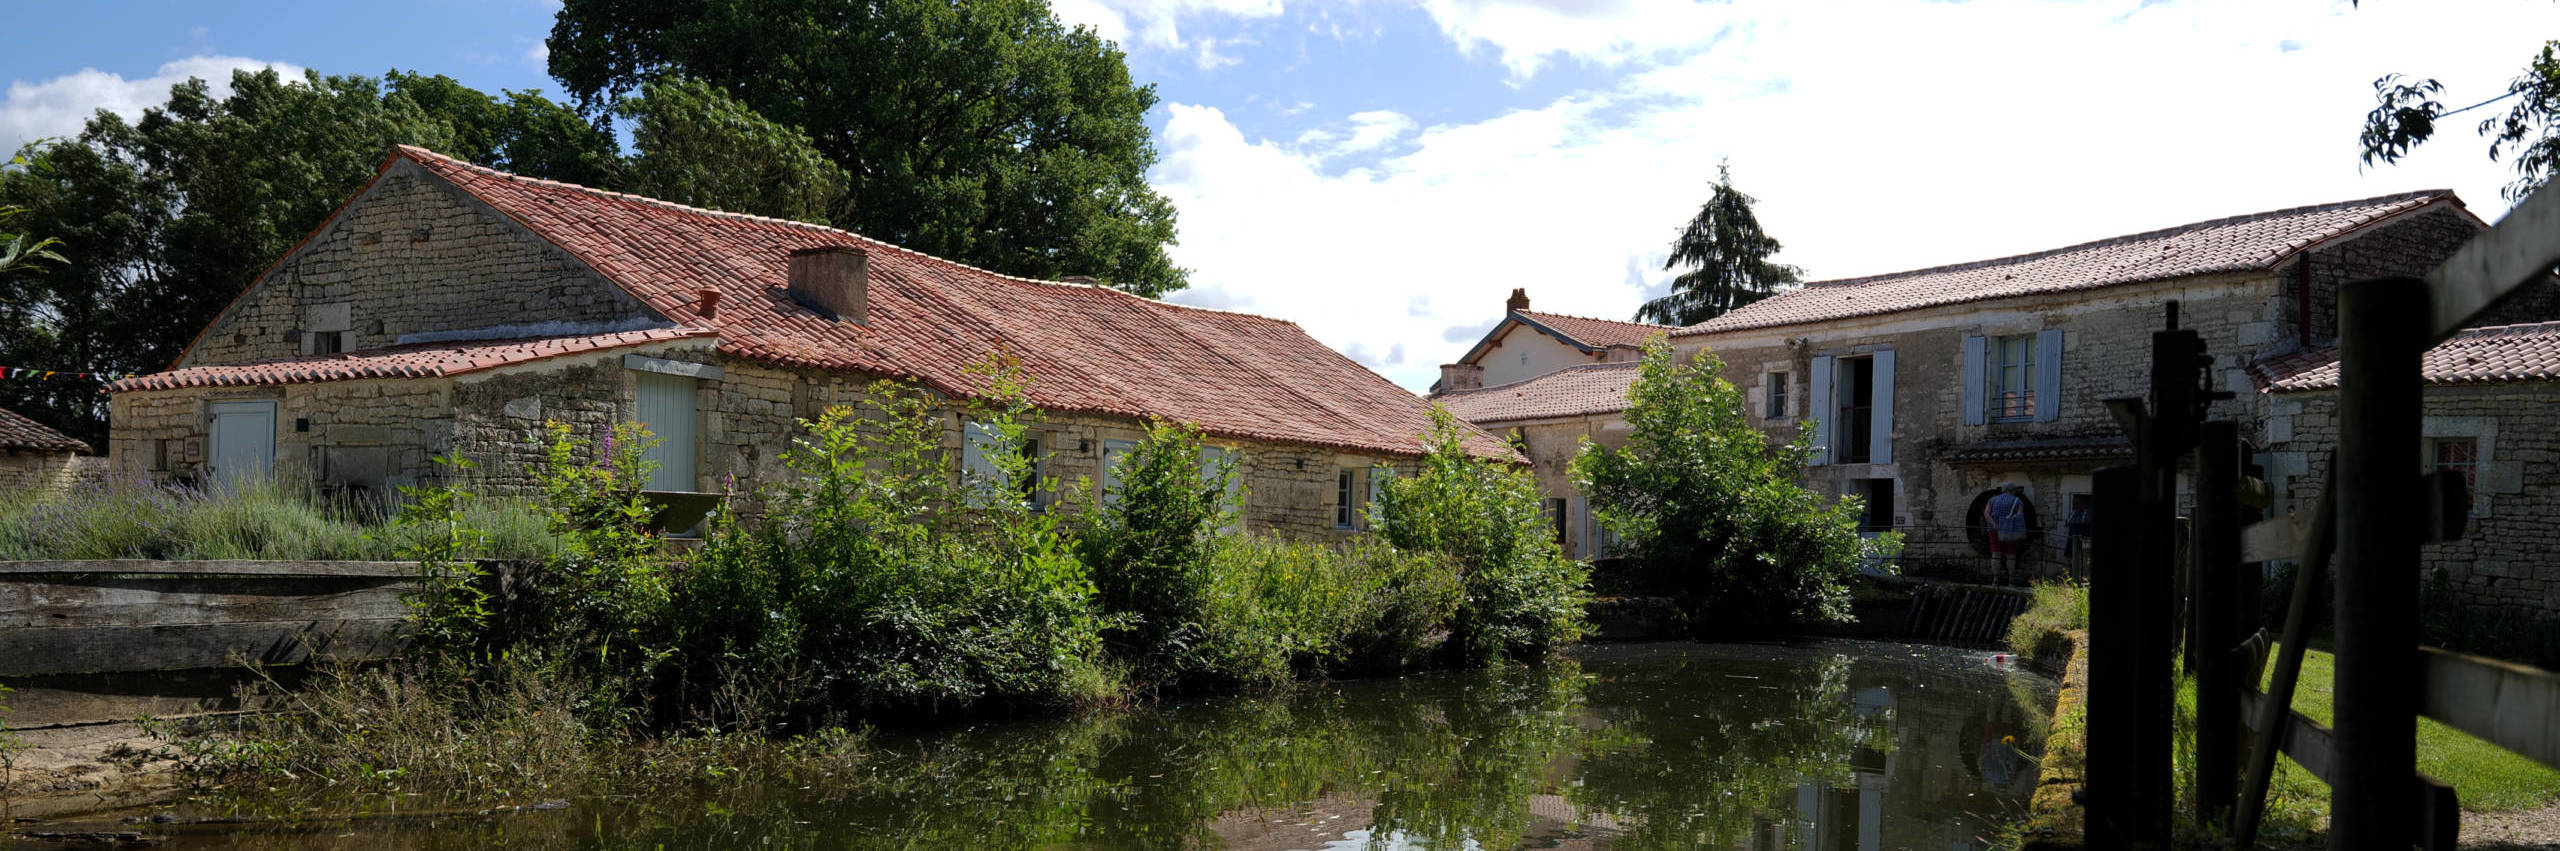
xmin=1431 ymin=361 xmax=1644 ymax=559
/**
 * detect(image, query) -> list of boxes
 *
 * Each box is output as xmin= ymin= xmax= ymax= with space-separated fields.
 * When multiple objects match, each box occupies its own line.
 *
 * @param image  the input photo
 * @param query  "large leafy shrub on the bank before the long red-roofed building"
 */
xmin=673 ymin=382 xmax=1108 ymax=723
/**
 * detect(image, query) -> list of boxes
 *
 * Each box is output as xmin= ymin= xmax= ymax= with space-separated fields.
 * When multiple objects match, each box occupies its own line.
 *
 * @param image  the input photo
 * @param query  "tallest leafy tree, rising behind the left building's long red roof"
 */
xmin=550 ymin=0 xmax=1185 ymax=295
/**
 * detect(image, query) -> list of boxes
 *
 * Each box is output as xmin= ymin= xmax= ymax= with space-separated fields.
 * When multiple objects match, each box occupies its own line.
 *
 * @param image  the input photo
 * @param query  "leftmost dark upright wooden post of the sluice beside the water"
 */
xmin=2081 ymin=467 xmax=2143 ymax=848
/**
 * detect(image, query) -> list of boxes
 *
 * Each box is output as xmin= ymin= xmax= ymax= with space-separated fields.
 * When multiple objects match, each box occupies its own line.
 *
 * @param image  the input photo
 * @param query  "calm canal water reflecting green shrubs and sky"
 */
xmin=115 ymin=641 xmax=2053 ymax=851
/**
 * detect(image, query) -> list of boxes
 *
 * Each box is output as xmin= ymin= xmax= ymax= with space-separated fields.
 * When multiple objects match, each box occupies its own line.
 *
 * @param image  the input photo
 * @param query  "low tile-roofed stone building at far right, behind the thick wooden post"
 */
xmin=2258 ymin=323 xmax=2560 ymax=615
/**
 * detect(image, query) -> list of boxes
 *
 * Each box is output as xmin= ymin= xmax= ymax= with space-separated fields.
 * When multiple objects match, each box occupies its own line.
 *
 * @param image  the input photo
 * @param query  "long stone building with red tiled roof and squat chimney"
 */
xmin=108 ymin=146 xmax=1516 ymax=533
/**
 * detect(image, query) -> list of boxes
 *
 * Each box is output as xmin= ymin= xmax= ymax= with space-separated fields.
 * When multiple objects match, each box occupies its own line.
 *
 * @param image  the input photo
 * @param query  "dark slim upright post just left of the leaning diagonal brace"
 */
xmin=2186 ymin=420 xmax=2255 ymax=823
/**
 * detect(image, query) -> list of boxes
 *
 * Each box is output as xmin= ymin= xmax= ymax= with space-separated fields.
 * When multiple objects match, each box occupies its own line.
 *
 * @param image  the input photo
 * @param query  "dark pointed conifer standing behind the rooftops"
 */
xmin=1636 ymin=164 xmax=1805 ymax=326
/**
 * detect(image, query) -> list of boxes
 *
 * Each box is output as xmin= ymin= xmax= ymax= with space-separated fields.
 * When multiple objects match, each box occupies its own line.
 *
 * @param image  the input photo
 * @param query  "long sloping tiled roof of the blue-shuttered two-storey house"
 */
xmin=1677 ymin=190 xmax=2460 ymax=336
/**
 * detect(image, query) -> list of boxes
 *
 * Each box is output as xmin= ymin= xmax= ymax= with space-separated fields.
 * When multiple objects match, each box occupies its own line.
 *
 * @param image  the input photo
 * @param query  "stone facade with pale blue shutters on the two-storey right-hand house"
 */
xmin=1674 ymin=205 xmax=2481 ymax=577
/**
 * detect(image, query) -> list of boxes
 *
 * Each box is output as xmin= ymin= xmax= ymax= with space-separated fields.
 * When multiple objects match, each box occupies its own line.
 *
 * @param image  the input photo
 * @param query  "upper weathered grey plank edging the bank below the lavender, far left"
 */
xmin=0 ymin=574 xmax=410 ymax=627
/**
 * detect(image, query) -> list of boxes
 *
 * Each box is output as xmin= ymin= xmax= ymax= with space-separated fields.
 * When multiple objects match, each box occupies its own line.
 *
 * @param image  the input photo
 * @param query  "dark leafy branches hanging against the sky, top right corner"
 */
xmin=2360 ymin=41 xmax=2560 ymax=202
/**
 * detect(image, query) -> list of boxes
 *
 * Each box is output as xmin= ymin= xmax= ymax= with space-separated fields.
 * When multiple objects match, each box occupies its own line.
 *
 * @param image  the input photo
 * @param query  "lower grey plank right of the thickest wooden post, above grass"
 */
xmin=2419 ymin=645 xmax=2560 ymax=766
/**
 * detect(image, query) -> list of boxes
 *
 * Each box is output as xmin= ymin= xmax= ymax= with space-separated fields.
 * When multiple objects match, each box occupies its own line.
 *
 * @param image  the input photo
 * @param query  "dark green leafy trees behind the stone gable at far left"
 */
xmin=0 ymin=69 xmax=617 ymax=443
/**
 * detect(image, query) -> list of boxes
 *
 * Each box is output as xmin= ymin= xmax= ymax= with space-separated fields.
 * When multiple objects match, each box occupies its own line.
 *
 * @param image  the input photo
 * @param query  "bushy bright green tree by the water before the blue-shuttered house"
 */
xmin=1572 ymin=341 xmax=1900 ymax=633
